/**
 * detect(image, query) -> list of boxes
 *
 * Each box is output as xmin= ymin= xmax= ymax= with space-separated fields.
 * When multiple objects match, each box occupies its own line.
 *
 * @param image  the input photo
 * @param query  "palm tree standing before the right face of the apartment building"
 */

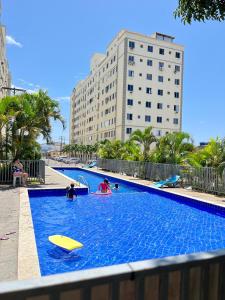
xmin=130 ymin=126 xmax=157 ymax=161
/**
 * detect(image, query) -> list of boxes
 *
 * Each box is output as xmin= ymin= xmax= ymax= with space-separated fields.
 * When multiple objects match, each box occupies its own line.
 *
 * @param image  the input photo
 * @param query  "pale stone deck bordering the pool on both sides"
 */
xmin=0 ymin=166 xmax=225 ymax=281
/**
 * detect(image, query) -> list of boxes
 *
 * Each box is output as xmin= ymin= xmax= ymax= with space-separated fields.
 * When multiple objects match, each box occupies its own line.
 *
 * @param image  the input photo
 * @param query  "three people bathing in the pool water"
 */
xmin=66 ymin=178 xmax=119 ymax=200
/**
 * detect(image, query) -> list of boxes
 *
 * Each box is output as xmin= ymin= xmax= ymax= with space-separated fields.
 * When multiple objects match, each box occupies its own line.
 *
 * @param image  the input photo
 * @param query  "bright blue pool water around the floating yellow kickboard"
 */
xmin=30 ymin=170 xmax=225 ymax=275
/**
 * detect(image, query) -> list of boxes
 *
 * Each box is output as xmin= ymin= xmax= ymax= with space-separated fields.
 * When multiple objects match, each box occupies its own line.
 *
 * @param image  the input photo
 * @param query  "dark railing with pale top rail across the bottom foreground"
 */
xmin=0 ymin=250 xmax=225 ymax=300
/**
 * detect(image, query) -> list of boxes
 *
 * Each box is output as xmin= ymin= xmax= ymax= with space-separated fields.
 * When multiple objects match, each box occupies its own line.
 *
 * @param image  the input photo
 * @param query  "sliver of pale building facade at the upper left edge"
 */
xmin=0 ymin=1 xmax=11 ymax=99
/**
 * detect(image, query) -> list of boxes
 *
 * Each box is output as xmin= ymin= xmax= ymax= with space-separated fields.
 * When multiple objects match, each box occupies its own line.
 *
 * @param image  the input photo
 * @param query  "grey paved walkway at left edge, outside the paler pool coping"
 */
xmin=0 ymin=186 xmax=20 ymax=281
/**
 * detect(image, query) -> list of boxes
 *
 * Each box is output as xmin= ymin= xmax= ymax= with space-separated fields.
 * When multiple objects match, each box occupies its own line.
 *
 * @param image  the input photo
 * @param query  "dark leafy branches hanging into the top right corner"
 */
xmin=174 ymin=0 xmax=225 ymax=24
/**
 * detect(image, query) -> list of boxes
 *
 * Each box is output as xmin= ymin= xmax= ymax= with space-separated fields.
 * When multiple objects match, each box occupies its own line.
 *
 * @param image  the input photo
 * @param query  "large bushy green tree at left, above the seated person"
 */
xmin=0 ymin=90 xmax=65 ymax=159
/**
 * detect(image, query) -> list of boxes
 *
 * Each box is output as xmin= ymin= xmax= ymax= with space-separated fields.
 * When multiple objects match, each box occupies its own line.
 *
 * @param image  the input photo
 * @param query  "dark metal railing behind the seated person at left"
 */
xmin=0 ymin=160 xmax=45 ymax=184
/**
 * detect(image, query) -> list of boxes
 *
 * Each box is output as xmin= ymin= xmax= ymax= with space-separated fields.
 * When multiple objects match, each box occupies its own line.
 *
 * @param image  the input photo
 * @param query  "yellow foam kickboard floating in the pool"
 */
xmin=48 ymin=235 xmax=83 ymax=251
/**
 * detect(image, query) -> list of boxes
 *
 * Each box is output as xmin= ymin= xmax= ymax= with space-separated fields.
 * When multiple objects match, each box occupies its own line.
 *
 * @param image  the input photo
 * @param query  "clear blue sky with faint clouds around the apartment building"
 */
xmin=2 ymin=0 xmax=225 ymax=143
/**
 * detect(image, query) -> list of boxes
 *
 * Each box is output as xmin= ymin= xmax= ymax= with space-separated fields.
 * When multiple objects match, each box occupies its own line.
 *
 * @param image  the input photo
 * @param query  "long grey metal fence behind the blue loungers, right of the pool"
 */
xmin=97 ymin=159 xmax=225 ymax=194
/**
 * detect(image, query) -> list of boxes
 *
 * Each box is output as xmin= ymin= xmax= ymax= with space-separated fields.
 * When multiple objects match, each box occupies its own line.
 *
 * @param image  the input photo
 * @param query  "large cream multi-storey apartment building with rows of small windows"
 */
xmin=70 ymin=30 xmax=184 ymax=144
